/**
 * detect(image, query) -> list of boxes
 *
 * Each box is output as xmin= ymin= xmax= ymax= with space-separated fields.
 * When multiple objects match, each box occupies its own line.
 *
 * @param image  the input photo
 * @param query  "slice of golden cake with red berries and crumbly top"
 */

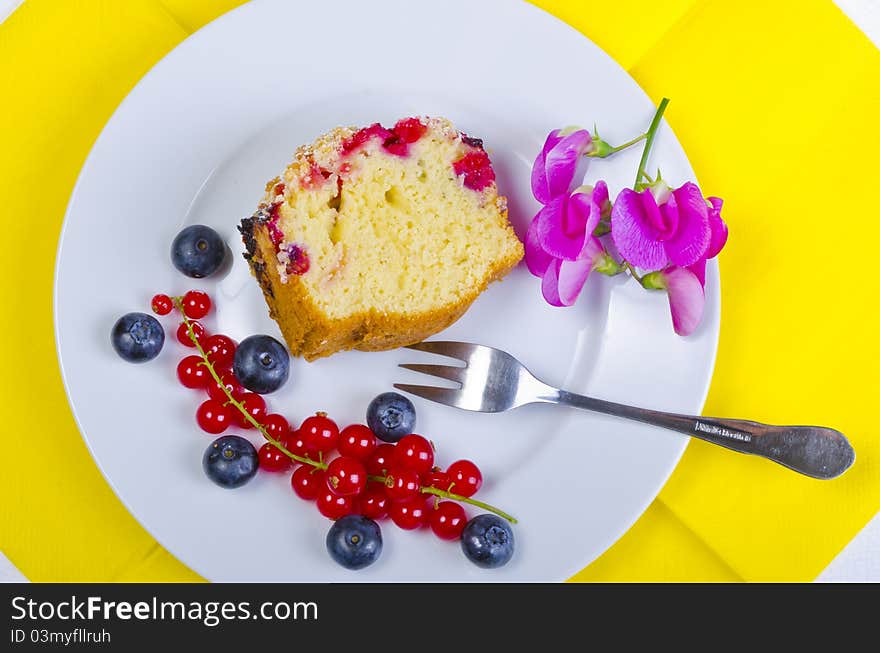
xmin=239 ymin=118 xmax=523 ymax=360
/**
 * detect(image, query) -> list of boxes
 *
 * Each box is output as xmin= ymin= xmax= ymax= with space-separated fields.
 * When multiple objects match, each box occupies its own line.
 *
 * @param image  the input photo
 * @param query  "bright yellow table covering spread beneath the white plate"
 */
xmin=0 ymin=0 xmax=880 ymax=581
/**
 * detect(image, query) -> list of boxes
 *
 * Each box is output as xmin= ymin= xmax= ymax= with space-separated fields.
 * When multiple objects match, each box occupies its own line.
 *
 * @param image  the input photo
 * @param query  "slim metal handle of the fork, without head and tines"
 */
xmin=550 ymin=390 xmax=856 ymax=479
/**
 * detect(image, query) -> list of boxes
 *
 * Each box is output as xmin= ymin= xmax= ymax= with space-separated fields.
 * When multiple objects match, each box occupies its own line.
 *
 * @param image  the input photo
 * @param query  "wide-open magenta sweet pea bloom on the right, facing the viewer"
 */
xmin=611 ymin=182 xmax=726 ymax=271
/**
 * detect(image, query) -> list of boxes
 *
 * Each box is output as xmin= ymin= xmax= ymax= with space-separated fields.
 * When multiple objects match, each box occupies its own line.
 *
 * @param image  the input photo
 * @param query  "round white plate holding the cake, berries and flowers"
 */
xmin=55 ymin=0 xmax=719 ymax=581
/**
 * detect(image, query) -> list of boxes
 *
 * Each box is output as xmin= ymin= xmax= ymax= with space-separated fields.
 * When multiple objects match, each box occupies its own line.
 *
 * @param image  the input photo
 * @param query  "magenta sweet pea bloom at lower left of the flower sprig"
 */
xmin=525 ymin=181 xmax=609 ymax=306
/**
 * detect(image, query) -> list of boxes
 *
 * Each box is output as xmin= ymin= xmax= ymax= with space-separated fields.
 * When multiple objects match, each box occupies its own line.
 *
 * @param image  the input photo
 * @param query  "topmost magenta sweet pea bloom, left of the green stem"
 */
xmin=532 ymin=129 xmax=593 ymax=204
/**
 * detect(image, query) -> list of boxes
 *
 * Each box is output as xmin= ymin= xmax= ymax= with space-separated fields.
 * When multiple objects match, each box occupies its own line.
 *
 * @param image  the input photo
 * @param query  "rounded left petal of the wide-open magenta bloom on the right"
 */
xmin=611 ymin=188 xmax=669 ymax=272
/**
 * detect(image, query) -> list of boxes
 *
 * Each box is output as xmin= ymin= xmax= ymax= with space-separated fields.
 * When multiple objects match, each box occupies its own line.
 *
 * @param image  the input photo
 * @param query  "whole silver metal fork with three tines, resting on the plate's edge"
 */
xmin=394 ymin=341 xmax=856 ymax=479
